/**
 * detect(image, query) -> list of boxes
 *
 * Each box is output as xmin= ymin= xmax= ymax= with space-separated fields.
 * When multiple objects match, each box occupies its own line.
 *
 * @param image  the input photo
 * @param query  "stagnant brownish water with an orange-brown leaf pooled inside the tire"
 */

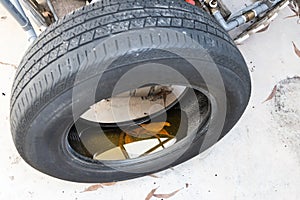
xmin=67 ymin=89 xmax=210 ymax=160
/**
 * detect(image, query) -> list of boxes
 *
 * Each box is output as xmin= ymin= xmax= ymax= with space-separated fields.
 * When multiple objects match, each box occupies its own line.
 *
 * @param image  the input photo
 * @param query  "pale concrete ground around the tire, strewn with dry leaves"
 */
xmin=0 ymin=1 xmax=300 ymax=200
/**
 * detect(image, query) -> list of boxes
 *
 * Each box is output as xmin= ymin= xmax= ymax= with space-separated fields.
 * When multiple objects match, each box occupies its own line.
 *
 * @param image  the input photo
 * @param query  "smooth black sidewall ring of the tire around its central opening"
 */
xmin=24 ymin=42 xmax=246 ymax=182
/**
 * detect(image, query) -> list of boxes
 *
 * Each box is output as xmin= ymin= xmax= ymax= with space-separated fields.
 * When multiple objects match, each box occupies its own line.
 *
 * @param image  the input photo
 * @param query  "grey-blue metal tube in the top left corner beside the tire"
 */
xmin=0 ymin=0 xmax=37 ymax=42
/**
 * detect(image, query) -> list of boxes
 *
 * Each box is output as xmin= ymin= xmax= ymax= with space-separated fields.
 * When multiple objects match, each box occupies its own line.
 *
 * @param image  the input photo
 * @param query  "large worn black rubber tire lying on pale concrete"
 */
xmin=10 ymin=0 xmax=251 ymax=182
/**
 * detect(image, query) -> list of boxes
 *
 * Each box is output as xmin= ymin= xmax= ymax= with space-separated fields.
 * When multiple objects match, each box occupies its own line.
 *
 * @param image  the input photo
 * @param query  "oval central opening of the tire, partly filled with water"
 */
xmin=67 ymin=86 xmax=210 ymax=161
